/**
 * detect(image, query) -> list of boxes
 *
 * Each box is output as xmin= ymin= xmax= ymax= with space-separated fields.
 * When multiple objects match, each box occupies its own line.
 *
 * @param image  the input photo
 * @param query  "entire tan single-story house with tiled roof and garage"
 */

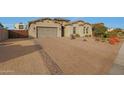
xmin=28 ymin=18 xmax=92 ymax=38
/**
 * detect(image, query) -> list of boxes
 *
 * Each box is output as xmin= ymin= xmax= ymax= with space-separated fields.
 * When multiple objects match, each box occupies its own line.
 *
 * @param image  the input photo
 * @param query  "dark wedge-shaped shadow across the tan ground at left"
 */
xmin=0 ymin=45 xmax=41 ymax=63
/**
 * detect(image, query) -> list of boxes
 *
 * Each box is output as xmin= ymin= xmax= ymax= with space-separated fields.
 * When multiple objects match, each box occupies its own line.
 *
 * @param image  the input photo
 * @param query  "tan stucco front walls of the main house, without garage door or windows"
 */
xmin=29 ymin=20 xmax=92 ymax=38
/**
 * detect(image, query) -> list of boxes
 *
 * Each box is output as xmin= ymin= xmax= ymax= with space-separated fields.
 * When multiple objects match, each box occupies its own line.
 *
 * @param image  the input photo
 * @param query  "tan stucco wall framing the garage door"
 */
xmin=29 ymin=20 xmax=61 ymax=38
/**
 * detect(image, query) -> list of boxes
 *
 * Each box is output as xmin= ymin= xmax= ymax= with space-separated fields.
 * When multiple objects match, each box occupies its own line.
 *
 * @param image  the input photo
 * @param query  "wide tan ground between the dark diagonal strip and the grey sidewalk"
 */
xmin=37 ymin=38 xmax=121 ymax=75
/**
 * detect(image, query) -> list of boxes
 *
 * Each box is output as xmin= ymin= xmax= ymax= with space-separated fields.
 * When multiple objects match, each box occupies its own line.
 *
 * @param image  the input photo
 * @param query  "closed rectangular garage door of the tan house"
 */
xmin=37 ymin=27 xmax=57 ymax=38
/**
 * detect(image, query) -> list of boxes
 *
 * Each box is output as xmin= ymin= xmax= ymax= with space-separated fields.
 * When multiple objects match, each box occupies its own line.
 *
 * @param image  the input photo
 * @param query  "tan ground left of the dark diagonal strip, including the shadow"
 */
xmin=0 ymin=39 xmax=50 ymax=75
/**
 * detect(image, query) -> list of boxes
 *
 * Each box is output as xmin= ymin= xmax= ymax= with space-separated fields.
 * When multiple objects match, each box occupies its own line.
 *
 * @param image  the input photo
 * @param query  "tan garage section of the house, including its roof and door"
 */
xmin=28 ymin=18 xmax=66 ymax=38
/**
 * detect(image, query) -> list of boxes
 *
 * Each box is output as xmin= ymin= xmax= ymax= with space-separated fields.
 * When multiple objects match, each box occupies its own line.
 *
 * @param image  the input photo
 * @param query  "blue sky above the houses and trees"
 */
xmin=0 ymin=17 xmax=124 ymax=29
